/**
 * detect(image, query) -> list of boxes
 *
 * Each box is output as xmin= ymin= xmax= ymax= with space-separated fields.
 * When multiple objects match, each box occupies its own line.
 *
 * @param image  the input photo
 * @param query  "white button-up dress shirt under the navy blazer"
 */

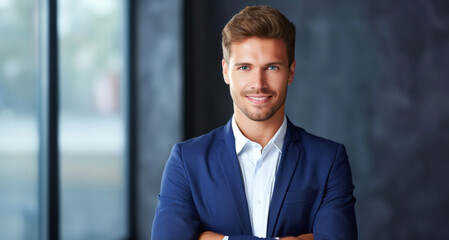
xmin=225 ymin=115 xmax=287 ymax=239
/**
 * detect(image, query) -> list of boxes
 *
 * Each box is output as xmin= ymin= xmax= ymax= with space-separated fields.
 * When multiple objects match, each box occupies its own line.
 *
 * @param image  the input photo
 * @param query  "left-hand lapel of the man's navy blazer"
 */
xmin=216 ymin=121 xmax=252 ymax=235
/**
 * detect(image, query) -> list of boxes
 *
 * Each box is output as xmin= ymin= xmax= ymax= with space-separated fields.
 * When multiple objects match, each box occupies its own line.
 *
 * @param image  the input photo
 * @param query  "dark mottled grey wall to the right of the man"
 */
xmin=280 ymin=1 xmax=449 ymax=239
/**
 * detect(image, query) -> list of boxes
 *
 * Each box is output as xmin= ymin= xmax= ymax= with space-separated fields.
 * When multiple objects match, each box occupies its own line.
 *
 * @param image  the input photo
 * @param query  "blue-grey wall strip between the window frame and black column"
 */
xmin=135 ymin=0 xmax=183 ymax=239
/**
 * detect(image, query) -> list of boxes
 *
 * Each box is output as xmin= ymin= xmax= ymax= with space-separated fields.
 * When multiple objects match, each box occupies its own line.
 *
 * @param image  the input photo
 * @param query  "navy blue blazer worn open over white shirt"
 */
xmin=152 ymin=121 xmax=357 ymax=240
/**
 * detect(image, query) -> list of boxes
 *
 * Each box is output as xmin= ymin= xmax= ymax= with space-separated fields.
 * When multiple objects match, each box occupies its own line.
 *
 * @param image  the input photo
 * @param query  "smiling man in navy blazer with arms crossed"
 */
xmin=152 ymin=6 xmax=357 ymax=240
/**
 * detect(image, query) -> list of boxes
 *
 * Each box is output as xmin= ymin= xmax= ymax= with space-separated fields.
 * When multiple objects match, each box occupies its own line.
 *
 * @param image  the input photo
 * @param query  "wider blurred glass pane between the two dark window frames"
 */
xmin=58 ymin=0 xmax=127 ymax=239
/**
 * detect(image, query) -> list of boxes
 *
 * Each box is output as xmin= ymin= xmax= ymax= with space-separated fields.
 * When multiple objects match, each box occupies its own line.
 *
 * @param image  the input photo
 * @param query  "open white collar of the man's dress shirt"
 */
xmin=232 ymin=115 xmax=287 ymax=155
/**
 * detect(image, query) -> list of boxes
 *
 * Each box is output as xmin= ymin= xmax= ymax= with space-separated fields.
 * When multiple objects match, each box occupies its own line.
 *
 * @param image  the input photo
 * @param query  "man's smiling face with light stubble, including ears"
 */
xmin=222 ymin=37 xmax=296 ymax=124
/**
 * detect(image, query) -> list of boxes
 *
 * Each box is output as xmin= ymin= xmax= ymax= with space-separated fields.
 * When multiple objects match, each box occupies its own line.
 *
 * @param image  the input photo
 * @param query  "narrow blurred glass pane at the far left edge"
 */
xmin=0 ymin=0 xmax=39 ymax=239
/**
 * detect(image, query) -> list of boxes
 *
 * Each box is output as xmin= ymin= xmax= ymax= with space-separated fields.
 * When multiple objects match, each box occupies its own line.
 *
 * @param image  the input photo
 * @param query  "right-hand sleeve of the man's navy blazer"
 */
xmin=313 ymin=145 xmax=357 ymax=240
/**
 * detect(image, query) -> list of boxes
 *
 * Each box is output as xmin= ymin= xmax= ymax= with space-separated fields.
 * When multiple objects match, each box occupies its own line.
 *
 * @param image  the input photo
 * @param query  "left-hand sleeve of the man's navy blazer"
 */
xmin=151 ymin=144 xmax=200 ymax=240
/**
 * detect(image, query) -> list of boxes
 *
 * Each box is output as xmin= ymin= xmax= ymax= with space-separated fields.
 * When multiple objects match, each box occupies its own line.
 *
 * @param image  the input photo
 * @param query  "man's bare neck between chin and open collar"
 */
xmin=234 ymin=107 xmax=284 ymax=148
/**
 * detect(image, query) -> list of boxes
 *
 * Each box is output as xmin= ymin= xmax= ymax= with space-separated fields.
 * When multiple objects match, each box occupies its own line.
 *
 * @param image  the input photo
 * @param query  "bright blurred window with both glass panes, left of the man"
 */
xmin=0 ymin=0 xmax=129 ymax=239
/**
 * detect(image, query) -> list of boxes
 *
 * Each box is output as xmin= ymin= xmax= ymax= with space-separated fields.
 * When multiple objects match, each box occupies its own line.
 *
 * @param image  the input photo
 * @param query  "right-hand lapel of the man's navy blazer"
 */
xmin=267 ymin=120 xmax=301 ymax=237
